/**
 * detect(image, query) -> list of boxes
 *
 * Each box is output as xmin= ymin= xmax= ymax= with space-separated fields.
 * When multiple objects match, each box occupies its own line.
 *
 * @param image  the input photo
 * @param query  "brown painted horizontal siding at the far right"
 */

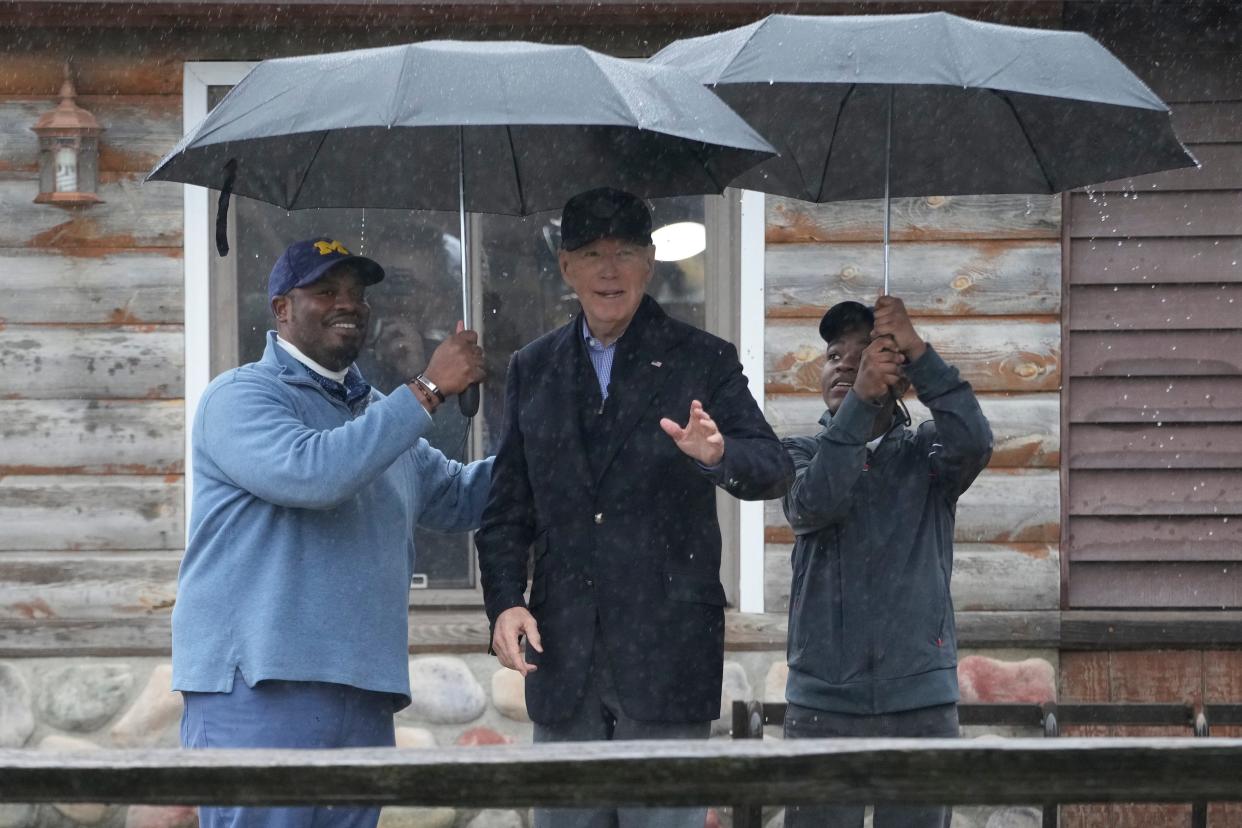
xmin=1062 ymin=84 xmax=1242 ymax=610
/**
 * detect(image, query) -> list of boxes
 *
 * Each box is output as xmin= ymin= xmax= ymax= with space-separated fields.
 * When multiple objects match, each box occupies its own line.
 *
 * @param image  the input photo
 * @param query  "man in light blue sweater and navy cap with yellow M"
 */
xmin=173 ymin=238 xmax=492 ymax=828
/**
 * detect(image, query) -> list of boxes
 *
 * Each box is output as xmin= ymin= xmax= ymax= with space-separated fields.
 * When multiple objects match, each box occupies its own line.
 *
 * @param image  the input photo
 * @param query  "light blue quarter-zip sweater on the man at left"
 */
xmin=173 ymin=331 xmax=492 ymax=703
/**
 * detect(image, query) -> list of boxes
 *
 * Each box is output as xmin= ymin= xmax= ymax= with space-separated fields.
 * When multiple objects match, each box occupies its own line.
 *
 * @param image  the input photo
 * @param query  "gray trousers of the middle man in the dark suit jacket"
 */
xmin=534 ymin=637 xmax=712 ymax=828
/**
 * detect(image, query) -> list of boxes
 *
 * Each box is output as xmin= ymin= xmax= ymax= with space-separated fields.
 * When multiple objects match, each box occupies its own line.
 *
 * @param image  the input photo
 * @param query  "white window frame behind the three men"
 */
xmin=181 ymin=61 xmax=765 ymax=612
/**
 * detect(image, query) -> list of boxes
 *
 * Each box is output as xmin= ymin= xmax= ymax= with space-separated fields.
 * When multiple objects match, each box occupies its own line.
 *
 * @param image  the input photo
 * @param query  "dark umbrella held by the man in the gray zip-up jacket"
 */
xmin=651 ymin=12 xmax=1195 ymax=293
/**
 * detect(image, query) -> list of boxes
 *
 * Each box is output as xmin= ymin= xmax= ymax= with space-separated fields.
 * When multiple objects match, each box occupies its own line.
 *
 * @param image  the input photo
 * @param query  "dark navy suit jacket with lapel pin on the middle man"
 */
xmin=476 ymin=297 xmax=794 ymax=722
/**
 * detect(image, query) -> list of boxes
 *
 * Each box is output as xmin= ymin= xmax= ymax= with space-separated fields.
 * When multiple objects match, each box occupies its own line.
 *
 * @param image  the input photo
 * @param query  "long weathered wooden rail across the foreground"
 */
xmin=0 ymin=739 xmax=1242 ymax=808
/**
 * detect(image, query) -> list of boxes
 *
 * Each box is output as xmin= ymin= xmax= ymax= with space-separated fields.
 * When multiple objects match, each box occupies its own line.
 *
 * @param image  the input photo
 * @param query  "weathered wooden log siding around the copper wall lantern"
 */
xmin=0 ymin=72 xmax=185 ymax=655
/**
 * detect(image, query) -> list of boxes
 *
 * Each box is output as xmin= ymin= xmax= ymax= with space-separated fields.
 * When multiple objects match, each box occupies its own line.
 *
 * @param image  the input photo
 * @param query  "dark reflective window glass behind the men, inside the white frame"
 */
xmin=211 ymin=186 xmax=705 ymax=588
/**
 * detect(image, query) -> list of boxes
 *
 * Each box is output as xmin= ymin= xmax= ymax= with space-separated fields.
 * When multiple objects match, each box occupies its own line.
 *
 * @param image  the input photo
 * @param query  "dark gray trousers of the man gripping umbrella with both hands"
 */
xmin=785 ymin=704 xmax=959 ymax=828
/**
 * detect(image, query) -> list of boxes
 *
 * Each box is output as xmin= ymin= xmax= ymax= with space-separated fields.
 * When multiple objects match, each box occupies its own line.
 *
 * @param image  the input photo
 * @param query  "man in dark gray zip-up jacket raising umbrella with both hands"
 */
xmin=784 ymin=297 xmax=992 ymax=828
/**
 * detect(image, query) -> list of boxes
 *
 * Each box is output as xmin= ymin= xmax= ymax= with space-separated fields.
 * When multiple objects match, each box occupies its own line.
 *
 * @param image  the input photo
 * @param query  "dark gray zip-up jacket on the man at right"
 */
xmin=782 ymin=345 xmax=992 ymax=715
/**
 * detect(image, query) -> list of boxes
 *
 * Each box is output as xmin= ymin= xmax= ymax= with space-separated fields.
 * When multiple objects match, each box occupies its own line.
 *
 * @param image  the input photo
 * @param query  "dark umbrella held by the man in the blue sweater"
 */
xmin=147 ymin=41 xmax=773 ymax=415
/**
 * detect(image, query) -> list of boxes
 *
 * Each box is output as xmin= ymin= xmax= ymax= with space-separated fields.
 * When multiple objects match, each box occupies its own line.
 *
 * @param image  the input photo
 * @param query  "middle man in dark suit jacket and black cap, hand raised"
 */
xmin=476 ymin=189 xmax=794 ymax=828
